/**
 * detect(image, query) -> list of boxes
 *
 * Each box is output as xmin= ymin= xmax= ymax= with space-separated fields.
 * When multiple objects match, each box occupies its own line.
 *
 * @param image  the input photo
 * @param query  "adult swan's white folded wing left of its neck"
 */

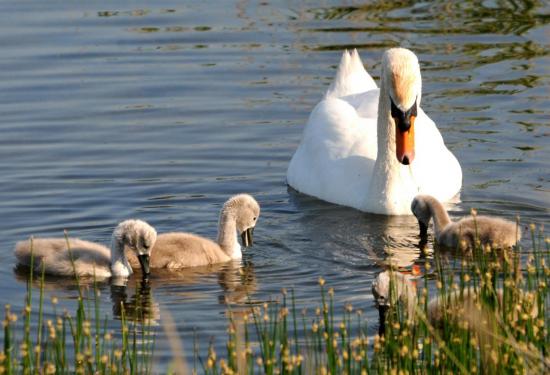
xmin=287 ymin=95 xmax=376 ymax=208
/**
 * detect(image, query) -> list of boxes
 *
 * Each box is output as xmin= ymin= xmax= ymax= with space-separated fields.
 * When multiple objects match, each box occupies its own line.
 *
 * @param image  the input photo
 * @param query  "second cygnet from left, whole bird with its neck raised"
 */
xmin=127 ymin=194 xmax=260 ymax=269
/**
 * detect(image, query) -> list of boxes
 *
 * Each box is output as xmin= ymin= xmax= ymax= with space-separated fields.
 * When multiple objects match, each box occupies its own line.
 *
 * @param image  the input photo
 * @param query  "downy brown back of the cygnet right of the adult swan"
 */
xmin=439 ymin=216 xmax=521 ymax=249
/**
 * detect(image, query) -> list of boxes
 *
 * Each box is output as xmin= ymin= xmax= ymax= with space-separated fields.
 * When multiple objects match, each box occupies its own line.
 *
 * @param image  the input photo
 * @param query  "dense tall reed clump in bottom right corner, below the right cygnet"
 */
xmin=374 ymin=226 xmax=550 ymax=374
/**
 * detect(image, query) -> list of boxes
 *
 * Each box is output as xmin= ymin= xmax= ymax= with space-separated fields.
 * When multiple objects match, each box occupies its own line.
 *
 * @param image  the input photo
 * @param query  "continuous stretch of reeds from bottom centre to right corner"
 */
xmin=195 ymin=226 xmax=550 ymax=374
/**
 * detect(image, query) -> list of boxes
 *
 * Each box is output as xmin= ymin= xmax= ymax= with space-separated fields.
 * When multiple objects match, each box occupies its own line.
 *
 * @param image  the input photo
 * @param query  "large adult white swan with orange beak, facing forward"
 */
xmin=287 ymin=48 xmax=462 ymax=215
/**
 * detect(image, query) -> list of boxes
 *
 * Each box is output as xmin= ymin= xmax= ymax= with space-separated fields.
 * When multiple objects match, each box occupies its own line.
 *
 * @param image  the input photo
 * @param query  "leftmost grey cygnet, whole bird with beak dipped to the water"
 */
xmin=15 ymin=220 xmax=157 ymax=278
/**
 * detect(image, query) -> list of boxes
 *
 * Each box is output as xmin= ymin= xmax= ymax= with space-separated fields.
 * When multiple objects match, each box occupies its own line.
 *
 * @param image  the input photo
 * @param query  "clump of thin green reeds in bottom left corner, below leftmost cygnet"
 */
xmin=0 ymin=239 xmax=154 ymax=374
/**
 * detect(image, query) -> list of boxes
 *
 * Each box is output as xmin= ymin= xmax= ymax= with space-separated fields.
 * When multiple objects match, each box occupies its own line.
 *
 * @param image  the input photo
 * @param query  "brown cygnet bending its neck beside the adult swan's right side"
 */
xmin=411 ymin=195 xmax=521 ymax=250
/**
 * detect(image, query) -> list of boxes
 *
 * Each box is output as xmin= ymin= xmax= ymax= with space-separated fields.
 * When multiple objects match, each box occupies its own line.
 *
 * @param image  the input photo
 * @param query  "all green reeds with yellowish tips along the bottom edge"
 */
xmin=0 ymin=226 xmax=550 ymax=374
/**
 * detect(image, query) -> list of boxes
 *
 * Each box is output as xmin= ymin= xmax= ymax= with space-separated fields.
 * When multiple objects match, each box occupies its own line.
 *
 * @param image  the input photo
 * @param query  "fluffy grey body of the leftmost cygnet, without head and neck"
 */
xmin=15 ymin=238 xmax=111 ymax=278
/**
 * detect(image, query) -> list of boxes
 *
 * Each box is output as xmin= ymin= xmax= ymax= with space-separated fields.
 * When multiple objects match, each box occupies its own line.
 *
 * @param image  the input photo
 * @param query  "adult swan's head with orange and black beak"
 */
xmin=380 ymin=48 xmax=422 ymax=165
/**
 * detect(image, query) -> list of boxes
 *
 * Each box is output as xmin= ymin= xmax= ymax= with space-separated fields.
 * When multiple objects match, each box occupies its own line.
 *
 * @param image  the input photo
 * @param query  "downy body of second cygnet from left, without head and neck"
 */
xmin=125 ymin=232 xmax=231 ymax=269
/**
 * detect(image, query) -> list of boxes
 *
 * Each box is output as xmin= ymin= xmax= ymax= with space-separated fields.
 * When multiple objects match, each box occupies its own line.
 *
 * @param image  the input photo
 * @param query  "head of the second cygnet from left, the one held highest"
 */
xmin=222 ymin=194 xmax=260 ymax=246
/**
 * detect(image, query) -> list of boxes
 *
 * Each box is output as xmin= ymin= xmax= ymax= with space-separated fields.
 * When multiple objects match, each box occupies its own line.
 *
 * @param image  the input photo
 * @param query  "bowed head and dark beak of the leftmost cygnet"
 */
xmin=113 ymin=219 xmax=157 ymax=275
